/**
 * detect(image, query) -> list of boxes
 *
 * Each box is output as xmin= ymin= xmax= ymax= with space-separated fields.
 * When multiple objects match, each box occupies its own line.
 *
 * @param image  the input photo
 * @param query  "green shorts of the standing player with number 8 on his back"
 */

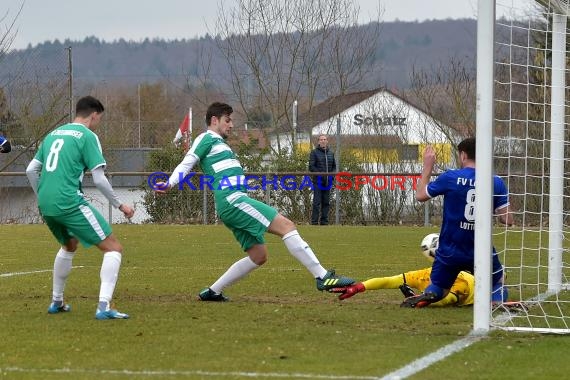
xmin=42 ymin=204 xmax=112 ymax=248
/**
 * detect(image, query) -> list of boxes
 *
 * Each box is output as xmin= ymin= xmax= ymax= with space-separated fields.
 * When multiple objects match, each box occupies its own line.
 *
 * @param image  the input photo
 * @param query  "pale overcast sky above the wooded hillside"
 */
xmin=0 ymin=0 xmax=477 ymax=49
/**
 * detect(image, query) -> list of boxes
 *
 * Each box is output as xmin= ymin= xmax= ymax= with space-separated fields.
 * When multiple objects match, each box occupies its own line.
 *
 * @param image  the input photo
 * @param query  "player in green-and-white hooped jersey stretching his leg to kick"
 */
xmin=155 ymin=103 xmax=354 ymax=301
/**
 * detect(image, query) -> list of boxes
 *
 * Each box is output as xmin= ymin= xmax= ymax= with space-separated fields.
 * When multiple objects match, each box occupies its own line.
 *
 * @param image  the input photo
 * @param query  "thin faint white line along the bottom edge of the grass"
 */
xmin=0 ymin=367 xmax=378 ymax=380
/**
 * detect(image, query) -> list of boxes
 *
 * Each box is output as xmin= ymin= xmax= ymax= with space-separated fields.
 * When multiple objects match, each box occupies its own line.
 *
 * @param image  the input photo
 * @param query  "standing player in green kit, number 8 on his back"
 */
xmin=26 ymin=96 xmax=134 ymax=319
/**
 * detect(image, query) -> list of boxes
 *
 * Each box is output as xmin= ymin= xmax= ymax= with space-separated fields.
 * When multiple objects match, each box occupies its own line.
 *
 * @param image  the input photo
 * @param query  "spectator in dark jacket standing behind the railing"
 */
xmin=309 ymin=135 xmax=336 ymax=225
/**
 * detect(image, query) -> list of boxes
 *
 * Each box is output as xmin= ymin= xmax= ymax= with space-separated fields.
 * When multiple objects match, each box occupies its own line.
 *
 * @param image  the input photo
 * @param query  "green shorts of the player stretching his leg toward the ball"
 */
xmin=220 ymin=195 xmax=277 ymax=251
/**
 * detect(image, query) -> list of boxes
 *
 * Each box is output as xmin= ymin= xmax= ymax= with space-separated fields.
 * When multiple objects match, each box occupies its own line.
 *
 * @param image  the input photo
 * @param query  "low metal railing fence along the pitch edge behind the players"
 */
xmin=0 ymin=172 xmax=441 ymax=225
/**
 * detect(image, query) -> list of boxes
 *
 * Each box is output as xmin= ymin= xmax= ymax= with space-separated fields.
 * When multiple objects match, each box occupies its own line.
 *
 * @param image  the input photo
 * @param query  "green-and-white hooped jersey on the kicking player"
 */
xmin=188 ymin=130 xmax=247 ymax=208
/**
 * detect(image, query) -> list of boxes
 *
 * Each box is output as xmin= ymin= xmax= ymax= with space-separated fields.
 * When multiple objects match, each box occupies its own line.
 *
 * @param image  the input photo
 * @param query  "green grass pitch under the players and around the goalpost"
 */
xmin=0 ymin=225 xmax=570 ymax=379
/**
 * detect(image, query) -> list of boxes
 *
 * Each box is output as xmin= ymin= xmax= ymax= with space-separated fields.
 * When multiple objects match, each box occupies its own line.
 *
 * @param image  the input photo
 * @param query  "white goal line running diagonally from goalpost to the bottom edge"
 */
xmin=381 ymin=332 xmax=486 ymax=380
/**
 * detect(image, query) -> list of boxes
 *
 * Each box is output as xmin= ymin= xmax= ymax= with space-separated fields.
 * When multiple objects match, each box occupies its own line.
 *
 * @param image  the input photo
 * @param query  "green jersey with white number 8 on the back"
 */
xmin=34 ymin=123 xmax=106 ymax=215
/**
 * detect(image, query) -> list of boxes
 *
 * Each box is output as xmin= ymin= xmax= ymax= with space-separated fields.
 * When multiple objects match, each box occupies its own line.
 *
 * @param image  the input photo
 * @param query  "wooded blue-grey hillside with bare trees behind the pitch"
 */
xmin=0 ymin=14 xmax=476 ymax=151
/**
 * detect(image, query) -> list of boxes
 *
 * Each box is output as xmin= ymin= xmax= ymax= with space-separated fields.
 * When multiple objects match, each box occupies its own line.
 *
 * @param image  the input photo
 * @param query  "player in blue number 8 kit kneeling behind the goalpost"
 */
xmin=401 ymin=138 xmax=513 ymax=308
